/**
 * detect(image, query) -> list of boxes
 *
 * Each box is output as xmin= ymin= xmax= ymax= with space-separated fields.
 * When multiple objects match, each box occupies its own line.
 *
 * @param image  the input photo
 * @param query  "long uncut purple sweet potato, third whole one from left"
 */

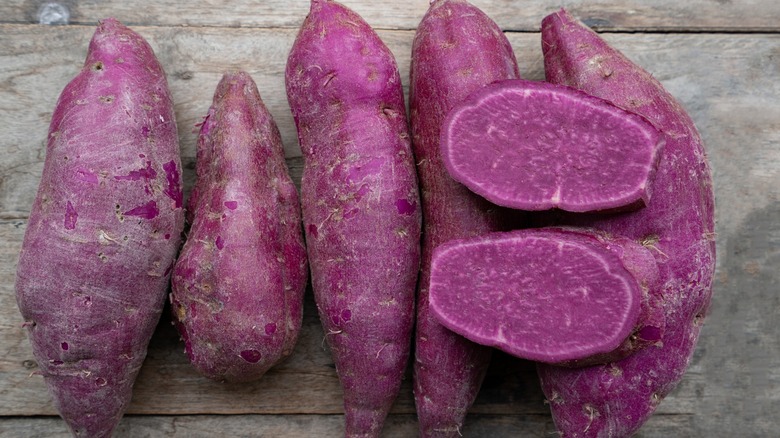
xmin=285 ymin=0 xmax=421 ymax=437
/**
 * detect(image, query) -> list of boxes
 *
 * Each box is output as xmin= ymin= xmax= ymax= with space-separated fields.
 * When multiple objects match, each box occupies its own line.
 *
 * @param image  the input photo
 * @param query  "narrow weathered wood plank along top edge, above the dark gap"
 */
xmin=0 ymin=0 xmax=780 ymax=31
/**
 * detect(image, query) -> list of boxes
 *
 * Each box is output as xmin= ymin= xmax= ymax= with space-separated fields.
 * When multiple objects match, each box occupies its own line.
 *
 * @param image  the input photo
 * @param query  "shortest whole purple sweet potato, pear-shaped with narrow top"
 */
xmin=171 ymin=72 xmax=308 ymax=382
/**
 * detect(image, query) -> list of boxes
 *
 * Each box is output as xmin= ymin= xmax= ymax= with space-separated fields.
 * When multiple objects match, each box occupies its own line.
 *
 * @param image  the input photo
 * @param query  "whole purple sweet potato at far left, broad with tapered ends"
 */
xmin=16 ymin=19 xmax=184 ymax=437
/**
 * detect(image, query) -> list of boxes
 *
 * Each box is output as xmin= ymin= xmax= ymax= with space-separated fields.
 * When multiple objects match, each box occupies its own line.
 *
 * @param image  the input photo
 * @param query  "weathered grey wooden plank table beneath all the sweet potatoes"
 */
xmin=0 ymin=0 xmax=780 ymax=437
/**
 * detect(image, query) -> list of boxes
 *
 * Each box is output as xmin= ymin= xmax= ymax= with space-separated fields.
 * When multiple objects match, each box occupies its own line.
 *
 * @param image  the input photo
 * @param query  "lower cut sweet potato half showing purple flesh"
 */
xmin=429 ymin=228 xmax=660 ymax=364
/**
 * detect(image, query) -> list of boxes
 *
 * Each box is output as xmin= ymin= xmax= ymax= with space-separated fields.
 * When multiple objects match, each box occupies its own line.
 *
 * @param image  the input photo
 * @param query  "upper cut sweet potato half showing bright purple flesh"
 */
xmin=441 ymin=79 xmax=663 ymax=212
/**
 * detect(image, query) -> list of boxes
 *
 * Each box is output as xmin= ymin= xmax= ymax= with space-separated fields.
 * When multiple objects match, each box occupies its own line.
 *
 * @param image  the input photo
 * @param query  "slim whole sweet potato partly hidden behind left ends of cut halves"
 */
xmin=409 ymin=0 xmax=520 ymax=437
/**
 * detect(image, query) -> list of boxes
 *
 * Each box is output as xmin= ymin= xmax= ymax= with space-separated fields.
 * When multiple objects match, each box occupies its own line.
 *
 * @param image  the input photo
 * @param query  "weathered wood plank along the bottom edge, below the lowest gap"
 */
xmin=0 ymin=414 xmax=696 ymax=438
